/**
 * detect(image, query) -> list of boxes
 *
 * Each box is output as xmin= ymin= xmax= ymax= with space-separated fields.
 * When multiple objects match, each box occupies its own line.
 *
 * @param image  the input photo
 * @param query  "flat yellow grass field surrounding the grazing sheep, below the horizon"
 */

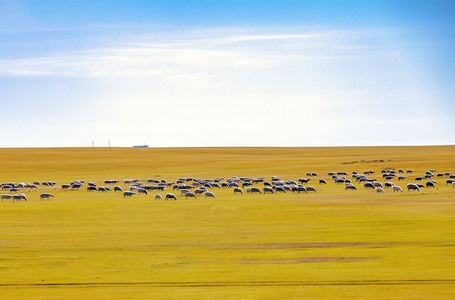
xmin=0 ymin=146 xmax=455 ymax=299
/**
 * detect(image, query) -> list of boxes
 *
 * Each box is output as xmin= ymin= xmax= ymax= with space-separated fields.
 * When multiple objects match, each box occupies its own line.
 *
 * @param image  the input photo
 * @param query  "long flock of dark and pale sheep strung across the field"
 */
xmin=1 ymin=169 xmax=455 ymax=202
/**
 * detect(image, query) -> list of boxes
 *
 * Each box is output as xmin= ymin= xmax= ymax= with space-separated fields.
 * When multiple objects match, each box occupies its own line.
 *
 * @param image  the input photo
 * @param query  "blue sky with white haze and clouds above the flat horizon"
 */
xmin=0 ymin=0 xmax=455 ymax=147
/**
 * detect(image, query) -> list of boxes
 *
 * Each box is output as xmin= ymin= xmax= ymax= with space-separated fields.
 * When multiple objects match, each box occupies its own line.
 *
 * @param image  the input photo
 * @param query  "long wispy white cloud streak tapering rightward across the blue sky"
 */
xmin=0 ymin=27 xmax=378 ymax=78
